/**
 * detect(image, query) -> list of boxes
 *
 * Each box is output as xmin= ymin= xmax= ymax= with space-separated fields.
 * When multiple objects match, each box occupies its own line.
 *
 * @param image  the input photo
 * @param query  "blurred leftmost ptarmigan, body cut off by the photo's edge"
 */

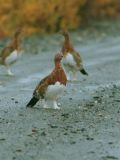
xmin=0 ymin=28 xmax=22 ymax=75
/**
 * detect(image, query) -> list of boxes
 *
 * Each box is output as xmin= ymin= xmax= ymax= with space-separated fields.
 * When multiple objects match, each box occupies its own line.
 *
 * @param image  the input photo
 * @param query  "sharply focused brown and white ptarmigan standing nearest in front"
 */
xmin=26 ymin=53 xmax=67 ymax=109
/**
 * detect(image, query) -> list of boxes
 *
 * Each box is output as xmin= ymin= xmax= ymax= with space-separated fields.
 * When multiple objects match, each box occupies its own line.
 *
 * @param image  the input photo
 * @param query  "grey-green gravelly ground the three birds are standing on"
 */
xmin=0 ymin=21 xmax=120 ymax=160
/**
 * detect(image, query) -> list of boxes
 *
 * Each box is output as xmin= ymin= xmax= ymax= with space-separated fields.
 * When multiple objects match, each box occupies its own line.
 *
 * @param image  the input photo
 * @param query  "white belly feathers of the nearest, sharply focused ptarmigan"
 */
xmin=45 ymin=82 xmax=66 ymax=100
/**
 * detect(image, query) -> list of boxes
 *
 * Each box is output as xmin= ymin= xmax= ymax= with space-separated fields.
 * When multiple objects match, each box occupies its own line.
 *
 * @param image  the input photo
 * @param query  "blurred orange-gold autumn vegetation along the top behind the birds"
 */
xmin=0 ymin=0 xmax=120 ymax=37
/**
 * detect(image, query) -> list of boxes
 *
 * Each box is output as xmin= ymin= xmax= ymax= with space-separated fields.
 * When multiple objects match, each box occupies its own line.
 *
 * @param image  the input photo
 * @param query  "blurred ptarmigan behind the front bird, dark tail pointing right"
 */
xmin=61 ymin=31 xmax=88 ymax=80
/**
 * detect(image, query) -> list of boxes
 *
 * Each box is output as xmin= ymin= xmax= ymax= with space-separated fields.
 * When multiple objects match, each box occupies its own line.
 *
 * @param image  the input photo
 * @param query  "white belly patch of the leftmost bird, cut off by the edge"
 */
xmin=5 ymin=50 xmax=18 ymax=64
